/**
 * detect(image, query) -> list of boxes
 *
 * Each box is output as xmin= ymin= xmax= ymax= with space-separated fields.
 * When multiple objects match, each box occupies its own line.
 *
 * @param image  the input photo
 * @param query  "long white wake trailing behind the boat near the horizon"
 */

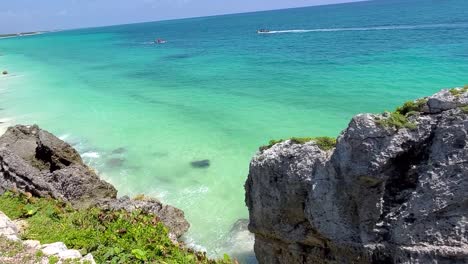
xmin=259 ymin=23 xmax=468 ymax=34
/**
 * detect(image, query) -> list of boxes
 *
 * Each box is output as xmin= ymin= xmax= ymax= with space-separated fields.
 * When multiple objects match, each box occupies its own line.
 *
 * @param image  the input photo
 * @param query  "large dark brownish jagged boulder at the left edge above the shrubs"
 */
xmin=0 ymin=125 xmax=117 ymax=207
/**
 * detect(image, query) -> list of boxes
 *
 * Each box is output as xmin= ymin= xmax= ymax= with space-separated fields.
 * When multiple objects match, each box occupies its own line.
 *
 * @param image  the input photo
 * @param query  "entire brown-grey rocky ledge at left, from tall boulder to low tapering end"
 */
xmin=0 ymin=125 xmax=190 ymax=239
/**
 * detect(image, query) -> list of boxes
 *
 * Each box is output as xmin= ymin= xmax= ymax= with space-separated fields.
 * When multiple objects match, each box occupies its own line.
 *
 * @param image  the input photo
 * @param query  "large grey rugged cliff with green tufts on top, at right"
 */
xmin=245 ymin=88 xmax=468 ymax=264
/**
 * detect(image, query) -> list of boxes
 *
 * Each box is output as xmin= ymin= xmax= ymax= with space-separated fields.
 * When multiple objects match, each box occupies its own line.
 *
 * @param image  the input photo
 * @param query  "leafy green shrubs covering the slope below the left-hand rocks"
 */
xmin=0 ymin=192 xmax=235 ymax=264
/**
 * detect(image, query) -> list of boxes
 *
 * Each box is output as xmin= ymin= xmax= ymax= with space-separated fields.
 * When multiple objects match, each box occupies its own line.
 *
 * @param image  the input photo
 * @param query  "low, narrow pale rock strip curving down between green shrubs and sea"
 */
xmin=99 ymin=196 xmax=190 ymax=237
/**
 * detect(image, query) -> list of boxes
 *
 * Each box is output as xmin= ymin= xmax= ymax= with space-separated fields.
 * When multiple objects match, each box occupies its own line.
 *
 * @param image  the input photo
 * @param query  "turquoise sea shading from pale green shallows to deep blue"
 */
xmin=0 ymin=0 xmax=468 ymax=260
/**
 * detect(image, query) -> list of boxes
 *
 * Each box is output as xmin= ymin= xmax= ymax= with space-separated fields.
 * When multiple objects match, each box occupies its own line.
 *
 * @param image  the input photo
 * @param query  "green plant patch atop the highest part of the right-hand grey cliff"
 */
xmin=376 ymin=99 xmax=427 ymax=129
